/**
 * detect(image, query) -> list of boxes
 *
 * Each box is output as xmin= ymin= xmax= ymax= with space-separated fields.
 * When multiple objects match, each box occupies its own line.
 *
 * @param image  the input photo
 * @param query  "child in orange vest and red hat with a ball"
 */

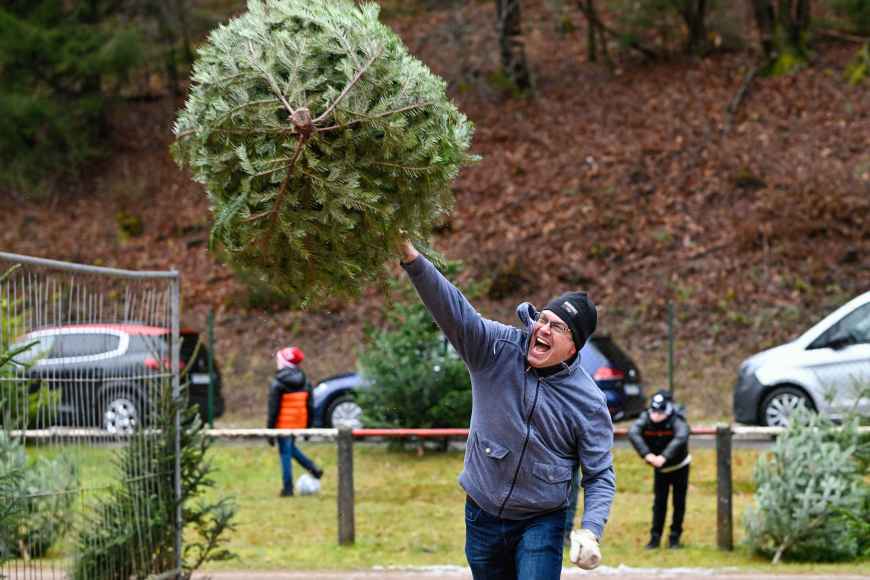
xmin=266 ymin=346 xmax=323 ymax=497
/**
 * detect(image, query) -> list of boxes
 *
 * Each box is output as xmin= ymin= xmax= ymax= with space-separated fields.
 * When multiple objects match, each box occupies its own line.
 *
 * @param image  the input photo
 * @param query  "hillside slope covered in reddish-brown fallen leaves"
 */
xmin=0 ymin=3 xmax=870 ymax=421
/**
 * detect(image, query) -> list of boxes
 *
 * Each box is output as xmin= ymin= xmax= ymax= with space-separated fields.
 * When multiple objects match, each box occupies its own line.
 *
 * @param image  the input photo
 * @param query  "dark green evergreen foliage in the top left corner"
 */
xmin=0 ymin=0 xmax=139 ymax=192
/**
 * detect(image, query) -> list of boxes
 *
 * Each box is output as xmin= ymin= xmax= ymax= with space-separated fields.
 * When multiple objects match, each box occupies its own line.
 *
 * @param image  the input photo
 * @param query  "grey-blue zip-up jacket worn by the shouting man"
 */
xmin=403 ymin=256 xmax=616 ymax=537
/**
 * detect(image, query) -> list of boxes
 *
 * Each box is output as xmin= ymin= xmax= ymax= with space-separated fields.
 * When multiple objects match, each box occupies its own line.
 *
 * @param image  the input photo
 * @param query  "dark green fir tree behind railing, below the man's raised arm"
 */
xmin=358 ymin=264 xmax=474 ymax=428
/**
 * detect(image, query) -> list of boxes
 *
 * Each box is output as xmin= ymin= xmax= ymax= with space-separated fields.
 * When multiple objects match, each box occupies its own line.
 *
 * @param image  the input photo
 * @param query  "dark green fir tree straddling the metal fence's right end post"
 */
xmin=70 ymin=388 xmax=236 ymax=580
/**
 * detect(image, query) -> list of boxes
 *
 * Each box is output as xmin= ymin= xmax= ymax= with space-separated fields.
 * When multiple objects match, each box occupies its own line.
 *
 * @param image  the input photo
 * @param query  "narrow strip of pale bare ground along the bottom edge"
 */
xmin=194 ymin=566 xmax=870 ymax=580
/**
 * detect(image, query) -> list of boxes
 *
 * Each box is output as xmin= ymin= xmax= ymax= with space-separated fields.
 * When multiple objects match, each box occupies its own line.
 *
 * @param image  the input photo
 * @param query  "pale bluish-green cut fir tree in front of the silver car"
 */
xmin=745 ymin=409 xmax=870 ymax=563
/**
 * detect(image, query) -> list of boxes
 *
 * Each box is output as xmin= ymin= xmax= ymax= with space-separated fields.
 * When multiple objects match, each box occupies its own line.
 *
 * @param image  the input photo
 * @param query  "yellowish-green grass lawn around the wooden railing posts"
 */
xmin=199 ymin=442 xmax=870 ymax=573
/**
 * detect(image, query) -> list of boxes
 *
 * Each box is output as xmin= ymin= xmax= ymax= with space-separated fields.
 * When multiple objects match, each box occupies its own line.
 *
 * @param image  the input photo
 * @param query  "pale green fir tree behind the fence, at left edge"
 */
xmin=0 ymin=431 xmax=79 ymax=560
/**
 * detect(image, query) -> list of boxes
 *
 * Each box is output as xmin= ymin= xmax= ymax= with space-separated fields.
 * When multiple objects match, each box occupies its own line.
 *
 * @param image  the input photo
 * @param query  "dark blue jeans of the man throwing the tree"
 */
xmin=465 ymin=497 xmax=565 ymax=580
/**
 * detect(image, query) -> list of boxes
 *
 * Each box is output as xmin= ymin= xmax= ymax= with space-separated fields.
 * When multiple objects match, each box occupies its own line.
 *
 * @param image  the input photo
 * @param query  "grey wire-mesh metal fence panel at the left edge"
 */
xmin=0 ymin=253 xmax=181 ymax=580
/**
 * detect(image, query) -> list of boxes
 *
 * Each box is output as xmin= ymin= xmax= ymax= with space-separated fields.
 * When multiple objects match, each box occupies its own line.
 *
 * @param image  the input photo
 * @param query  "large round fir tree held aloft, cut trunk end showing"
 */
xmin=173 ymin=0 xmax=474 ymax=305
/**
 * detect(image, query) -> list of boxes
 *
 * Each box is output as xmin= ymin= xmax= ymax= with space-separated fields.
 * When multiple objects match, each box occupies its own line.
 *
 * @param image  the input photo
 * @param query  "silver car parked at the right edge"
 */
xmin=734 ymin=292 xmax=870 ymax=426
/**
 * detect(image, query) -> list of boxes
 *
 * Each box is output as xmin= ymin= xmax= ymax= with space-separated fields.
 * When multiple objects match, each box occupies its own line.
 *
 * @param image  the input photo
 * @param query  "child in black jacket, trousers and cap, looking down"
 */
xmin=628 ymin=390 xmax=692 ymax=550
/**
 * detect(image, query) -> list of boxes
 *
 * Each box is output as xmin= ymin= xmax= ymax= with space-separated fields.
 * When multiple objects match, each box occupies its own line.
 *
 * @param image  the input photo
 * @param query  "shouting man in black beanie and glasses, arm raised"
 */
xmin=399 ymin=241 xmax=616 ymax=580
